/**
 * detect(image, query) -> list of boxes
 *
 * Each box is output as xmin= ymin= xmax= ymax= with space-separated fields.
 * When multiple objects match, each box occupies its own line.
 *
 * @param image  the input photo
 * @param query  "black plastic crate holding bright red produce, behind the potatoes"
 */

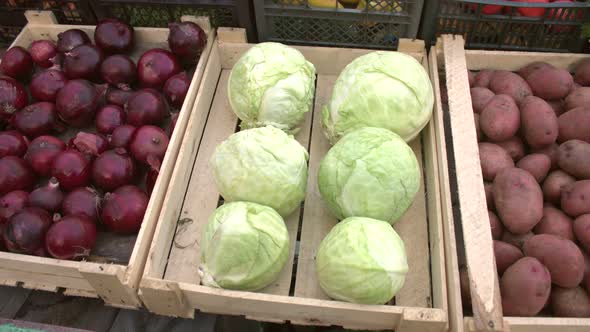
xmin=420 ymin=0 xmax=590 ymax=52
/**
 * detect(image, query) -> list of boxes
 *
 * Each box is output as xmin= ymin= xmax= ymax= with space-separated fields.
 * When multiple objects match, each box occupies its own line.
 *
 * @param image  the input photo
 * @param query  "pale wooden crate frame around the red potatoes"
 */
xmin=440 ymin=35 xmax=590 ymax=332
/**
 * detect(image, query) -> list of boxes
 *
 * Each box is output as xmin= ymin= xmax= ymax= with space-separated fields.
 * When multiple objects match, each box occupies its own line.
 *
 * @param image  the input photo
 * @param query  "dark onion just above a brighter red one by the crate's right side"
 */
xmin=125 ymin=89 xmax=169 ymax=127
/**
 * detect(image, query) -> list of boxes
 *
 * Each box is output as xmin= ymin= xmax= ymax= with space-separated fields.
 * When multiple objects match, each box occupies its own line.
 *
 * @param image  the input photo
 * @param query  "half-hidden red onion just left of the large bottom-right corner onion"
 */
xmin=61 ymin=187 xmax=101 ymax=222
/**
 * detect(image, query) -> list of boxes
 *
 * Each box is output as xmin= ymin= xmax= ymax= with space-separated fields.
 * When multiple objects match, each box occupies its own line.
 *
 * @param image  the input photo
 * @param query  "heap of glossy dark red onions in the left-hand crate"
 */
xmin=0 ymin=19 xmax=207 ymax=260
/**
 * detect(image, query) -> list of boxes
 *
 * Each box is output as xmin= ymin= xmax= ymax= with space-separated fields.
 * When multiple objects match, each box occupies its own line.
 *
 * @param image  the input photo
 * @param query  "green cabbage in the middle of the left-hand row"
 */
xmin=210 ymin=126 xmax=309 ymax=217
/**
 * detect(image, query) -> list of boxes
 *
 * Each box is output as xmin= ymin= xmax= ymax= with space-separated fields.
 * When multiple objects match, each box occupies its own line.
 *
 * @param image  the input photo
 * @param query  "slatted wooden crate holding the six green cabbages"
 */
xmin=140 ymin=28 xmax=452 ymax=331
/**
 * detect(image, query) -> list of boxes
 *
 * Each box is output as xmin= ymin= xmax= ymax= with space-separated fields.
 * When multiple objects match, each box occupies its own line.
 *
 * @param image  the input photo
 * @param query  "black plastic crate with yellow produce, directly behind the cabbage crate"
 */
xmin=254 ymin=0 xmax=424 ymax=49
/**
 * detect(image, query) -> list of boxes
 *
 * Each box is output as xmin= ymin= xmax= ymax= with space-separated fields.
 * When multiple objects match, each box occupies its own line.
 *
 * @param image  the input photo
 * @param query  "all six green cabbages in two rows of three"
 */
xmin=199 ymin=43 xmax=434 ymax=304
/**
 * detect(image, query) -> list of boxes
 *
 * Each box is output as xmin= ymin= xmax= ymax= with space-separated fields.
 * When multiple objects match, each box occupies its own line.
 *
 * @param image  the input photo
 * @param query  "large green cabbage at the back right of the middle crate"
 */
xmin=322 ymin=51 xmax=434 ymax=143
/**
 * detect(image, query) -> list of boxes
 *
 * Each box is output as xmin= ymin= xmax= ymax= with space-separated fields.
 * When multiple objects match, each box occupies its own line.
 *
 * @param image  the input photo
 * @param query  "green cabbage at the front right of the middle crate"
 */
xmin=316 ymin=217 xmax=408 ymax=304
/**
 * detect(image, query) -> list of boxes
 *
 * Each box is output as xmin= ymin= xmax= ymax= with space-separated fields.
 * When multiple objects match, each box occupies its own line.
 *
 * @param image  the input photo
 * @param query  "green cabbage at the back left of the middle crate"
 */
xmin=228 ymin=43 xmax=316 ymax=132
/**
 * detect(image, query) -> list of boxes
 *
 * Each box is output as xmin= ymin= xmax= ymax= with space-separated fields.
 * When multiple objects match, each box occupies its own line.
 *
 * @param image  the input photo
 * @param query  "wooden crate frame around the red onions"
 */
xmin=0 ymin=11 xmax=215 ymax=308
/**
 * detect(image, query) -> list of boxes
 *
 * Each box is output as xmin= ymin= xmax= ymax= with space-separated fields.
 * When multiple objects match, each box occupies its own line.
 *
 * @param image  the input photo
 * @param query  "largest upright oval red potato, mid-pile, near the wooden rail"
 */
xmin=493 ymin=168 xmax=543 ymax=234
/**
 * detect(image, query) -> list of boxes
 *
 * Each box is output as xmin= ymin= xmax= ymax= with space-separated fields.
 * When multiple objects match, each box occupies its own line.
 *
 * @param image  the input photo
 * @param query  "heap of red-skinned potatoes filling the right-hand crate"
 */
xmin=468 ymin=61 xmax=590 ymax=317
